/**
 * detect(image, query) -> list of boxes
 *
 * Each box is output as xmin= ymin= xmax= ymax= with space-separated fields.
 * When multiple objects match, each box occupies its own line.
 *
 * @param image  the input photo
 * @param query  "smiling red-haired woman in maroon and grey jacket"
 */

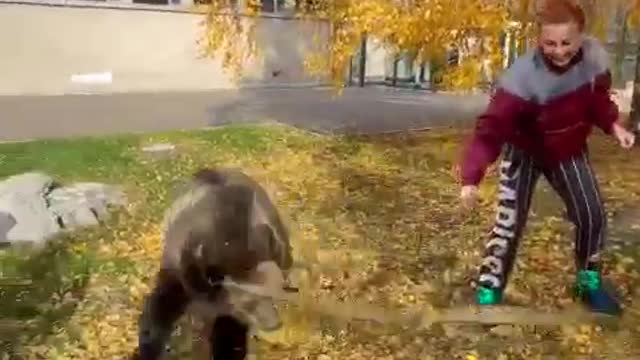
xmin=461 ymin=0 xmax=635 ymax=314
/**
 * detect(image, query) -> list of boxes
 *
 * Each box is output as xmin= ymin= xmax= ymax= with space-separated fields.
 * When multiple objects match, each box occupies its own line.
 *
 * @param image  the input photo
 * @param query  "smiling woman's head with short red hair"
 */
xmin=538 ymin=0 xmax=585 ymax=67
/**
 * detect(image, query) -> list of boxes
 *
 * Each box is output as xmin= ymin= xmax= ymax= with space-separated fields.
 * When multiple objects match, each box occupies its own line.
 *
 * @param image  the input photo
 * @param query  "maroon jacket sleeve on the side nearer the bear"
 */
xmin=460 ymin=88 xmax=529 ymax=185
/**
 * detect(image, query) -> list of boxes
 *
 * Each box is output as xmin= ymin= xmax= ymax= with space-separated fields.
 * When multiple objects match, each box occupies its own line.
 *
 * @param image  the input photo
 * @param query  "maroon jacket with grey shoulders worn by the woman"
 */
xmin=461 ymin=38 xmax=618 ymax=185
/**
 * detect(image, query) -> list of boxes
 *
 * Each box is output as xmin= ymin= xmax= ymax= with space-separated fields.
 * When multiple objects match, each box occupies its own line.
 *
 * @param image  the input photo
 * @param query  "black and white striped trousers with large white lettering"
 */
xmin=478 ymin=145 xmax=607 ymax=289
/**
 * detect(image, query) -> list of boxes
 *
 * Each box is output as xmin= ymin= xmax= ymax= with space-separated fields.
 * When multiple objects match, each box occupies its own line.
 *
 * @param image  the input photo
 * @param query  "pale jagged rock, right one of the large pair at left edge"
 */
xmin=46 ymin=183 xmax=126 ymax=228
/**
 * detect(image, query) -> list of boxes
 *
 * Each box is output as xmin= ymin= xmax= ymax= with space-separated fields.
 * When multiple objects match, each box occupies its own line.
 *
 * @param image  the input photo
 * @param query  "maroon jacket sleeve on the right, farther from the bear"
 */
xmin=591 ymin=71 xmax=619 ymax=134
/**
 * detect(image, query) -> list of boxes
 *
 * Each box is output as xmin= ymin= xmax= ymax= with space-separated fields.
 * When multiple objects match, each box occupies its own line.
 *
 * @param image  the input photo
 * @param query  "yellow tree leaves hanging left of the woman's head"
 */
xmin=201 ymin=0 xmax=509 ymax=88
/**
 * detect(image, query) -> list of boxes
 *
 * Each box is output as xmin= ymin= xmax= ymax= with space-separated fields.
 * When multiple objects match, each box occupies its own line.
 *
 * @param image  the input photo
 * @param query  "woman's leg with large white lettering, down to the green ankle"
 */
xmin=477 ymin=145 xmax=540 ymax=305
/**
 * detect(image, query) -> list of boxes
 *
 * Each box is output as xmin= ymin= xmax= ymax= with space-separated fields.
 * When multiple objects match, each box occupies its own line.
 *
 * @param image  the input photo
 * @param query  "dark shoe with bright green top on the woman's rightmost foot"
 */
xmin=575 ymin=270 xmax=622 ymax=315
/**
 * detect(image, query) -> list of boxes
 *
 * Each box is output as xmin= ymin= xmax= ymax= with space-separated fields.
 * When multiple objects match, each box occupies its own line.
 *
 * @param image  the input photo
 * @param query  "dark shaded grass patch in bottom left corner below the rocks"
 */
xmin=0 ymin=237 xmax=95 ymax=359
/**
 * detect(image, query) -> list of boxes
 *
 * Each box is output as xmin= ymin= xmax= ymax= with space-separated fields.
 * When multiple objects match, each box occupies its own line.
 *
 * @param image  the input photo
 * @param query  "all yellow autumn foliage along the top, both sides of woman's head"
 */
xmin=195 ymin=0 xmax=639 ymax=94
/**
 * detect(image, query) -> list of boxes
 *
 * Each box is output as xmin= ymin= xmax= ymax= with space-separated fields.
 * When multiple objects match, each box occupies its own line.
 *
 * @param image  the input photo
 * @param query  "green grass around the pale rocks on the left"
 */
xmin=0 ymin=126 xmax=320 ymax=353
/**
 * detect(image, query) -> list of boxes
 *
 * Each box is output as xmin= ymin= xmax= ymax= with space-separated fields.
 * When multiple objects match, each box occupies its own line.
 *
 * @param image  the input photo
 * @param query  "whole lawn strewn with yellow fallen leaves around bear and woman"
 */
xmin=0 ymin=125 xmax=640 ymax=360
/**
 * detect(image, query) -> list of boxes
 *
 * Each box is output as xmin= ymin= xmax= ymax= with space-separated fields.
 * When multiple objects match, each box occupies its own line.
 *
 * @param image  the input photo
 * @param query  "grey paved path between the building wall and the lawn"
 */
xmin=0 ymin=88 xmax=486 ymax=141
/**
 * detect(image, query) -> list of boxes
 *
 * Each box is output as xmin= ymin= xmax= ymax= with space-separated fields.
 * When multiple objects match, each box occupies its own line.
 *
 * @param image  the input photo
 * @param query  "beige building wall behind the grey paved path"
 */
xmin=0 ymin=1 xmax=329 ymax=95
